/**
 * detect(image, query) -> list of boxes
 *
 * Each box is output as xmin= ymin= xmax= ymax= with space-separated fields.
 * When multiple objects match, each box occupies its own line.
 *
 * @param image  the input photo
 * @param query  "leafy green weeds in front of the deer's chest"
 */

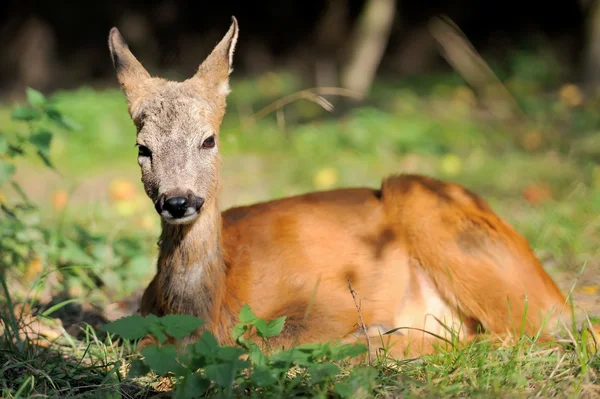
xmin=103 ymin=305 xmax=377 ymax=399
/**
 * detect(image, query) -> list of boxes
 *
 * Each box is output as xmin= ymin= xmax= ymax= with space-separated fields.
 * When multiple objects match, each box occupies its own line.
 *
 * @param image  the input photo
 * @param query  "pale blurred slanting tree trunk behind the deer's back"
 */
xmin=342 ymin=0 xmax=396 ymax=95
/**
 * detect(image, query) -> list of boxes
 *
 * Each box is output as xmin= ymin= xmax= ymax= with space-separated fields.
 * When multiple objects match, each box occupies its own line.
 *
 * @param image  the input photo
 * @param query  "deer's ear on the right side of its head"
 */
xmin=193 ymin=17 xmax=239 ymax=95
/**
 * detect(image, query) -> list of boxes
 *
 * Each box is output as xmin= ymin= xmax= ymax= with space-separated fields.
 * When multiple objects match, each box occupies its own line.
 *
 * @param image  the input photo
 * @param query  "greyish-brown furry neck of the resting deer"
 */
xmin=157 ymin=199 xmax=225 ymax=328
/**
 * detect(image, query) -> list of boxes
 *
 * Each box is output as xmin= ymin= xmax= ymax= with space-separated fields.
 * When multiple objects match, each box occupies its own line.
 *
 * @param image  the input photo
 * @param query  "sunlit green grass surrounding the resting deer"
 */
xmin=0 ymin=57 xmax=600 ymax=398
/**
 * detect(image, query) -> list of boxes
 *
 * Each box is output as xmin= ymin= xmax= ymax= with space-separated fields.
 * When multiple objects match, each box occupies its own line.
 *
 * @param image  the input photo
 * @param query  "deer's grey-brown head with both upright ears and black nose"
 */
xmin=108 ymin=17 xmax=238 ymax=224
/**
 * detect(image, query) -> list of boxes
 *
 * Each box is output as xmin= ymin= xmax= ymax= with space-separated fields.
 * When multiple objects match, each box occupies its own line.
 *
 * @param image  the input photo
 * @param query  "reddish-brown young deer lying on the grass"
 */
xmin=109 ymin=18 xmax=571 ymax=358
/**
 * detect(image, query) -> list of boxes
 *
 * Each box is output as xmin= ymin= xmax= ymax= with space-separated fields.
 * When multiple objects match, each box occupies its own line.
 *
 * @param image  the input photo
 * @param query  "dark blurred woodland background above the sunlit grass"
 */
xmin=0 ymin=0 xmax=584 ymax=97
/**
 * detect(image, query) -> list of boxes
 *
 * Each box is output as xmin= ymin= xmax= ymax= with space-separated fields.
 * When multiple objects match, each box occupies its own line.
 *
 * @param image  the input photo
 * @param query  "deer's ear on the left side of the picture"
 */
xmin=108 ymin=28 xmax=150 ymax=106
